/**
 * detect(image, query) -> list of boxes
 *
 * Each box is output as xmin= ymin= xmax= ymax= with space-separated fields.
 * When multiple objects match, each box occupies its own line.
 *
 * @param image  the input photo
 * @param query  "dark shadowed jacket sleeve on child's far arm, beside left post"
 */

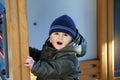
xmin=29 ymin=47 xmax=41 ymax=62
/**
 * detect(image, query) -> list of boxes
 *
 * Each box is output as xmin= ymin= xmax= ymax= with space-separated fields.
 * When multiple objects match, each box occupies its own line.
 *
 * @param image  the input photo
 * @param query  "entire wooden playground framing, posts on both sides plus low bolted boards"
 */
xmin=0 ymin=0 xmax=119 ymax=80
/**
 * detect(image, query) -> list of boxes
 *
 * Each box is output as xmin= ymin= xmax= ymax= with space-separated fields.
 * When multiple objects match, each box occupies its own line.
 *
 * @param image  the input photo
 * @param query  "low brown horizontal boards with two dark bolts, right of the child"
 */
xmin=80 ymin=60 xmax=100 ymax=80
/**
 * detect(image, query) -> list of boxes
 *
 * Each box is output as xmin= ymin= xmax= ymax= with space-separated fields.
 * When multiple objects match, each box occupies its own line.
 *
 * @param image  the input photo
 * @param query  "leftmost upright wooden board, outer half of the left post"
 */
xmin=6 ymin=0 xmax=21 ymax=80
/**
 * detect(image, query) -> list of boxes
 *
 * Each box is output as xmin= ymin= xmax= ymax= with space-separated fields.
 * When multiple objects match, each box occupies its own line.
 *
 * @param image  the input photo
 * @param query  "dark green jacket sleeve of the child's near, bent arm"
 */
xmin=31 ymin=54 xmax=79 ymax=79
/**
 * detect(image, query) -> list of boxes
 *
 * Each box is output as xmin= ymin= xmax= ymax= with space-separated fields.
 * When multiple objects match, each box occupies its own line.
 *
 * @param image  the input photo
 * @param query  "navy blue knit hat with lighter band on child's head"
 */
xmin=49 ymin=15 xmax=76 ymax=38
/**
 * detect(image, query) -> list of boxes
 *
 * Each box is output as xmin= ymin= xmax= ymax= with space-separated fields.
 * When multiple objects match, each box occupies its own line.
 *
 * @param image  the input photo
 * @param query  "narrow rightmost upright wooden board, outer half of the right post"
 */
xmin=108 ymin=0 xmax=114 ymax=80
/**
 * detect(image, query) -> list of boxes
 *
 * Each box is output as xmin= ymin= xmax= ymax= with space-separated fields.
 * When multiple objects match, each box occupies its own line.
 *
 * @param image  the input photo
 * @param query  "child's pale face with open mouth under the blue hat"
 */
xmin=50 ymin=32 xmax=72 ymax=50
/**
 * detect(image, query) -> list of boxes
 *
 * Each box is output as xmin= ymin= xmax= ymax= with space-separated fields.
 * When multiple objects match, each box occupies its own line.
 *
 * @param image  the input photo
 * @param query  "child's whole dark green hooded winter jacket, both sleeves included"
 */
xmin=30 ymin=30 xmax=87 ymax=80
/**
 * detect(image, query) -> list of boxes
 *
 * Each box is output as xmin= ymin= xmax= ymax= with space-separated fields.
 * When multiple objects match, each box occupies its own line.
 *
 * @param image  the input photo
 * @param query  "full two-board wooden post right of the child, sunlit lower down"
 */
xmin=97 ymin=0 xmax=114 ymax=80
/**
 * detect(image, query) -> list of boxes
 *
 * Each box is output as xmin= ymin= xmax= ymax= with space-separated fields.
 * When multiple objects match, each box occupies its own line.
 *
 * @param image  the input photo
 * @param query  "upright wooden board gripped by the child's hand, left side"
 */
xmin=18 ymin=0 xmax=30 ymax=80
